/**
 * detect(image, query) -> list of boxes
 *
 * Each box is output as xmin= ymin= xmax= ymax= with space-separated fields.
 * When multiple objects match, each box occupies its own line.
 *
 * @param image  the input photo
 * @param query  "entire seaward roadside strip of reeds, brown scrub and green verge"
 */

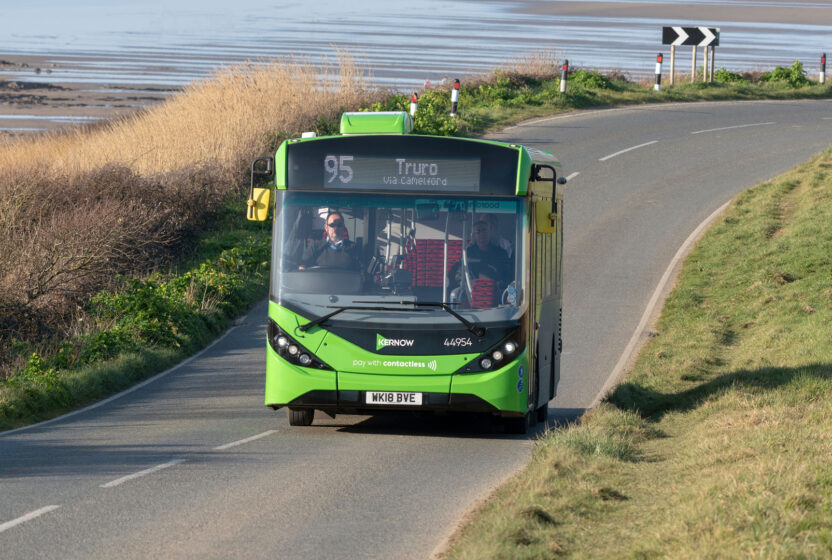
xmin=0 ymin=53 xmax=832 ymax=429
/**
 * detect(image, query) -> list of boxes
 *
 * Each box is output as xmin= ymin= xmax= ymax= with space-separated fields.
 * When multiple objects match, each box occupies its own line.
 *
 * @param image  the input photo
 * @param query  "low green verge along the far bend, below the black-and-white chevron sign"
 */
xmin=366 ymin=61 xmax=832 ymax=136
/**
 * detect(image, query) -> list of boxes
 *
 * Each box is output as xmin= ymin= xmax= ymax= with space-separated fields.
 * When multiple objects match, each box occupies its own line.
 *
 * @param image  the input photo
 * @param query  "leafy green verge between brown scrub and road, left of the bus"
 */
xmin=0 ymin=208 xmax=271 ymax=429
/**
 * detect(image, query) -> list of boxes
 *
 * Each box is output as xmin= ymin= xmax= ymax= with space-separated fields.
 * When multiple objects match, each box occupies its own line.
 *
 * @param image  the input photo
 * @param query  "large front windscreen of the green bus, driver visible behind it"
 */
xmin=271 ymin=191 xmax=529 ymax=328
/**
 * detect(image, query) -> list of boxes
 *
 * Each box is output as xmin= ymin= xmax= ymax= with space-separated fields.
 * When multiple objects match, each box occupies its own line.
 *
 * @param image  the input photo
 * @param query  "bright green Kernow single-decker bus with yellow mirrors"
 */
xmin=247 ymin=112 xmax=565 ymax=433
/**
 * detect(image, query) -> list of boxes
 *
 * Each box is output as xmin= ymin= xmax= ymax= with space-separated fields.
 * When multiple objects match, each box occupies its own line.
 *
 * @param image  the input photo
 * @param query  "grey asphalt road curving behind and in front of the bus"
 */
xmin=0 ymin=101 xmax=832 ymax=559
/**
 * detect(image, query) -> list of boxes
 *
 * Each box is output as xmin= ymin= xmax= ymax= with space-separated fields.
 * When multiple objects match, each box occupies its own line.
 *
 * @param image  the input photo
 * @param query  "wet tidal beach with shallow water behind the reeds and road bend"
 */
xmin=0 ymin=0 xmax=832 ymax=139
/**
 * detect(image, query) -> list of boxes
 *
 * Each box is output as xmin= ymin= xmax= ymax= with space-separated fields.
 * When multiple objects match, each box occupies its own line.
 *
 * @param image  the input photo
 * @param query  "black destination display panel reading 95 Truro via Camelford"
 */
xmin=286 ymin=135 xmax=518 ymax=196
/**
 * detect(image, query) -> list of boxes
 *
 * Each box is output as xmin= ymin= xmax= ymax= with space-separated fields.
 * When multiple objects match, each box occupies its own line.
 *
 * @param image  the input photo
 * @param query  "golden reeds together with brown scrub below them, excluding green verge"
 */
xmin=0 ymin=52 xmax=382 ymax=362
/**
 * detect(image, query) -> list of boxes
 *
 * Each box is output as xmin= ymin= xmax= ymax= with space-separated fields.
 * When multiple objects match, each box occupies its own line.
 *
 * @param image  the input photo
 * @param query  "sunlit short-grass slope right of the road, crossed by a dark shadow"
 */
xmin=446 ymin=149 xmax=832 ymax=559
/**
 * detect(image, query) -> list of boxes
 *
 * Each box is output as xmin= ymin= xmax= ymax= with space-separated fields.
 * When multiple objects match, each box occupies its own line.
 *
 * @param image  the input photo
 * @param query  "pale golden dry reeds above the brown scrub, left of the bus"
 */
xmin=0 ymin=52 xmax=370 ymax=176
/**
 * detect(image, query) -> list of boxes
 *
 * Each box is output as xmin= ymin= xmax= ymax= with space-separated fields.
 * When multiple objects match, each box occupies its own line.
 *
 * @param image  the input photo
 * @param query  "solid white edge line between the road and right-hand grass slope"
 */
xmin=589 ymin=200 xmax=731 ymax=408
